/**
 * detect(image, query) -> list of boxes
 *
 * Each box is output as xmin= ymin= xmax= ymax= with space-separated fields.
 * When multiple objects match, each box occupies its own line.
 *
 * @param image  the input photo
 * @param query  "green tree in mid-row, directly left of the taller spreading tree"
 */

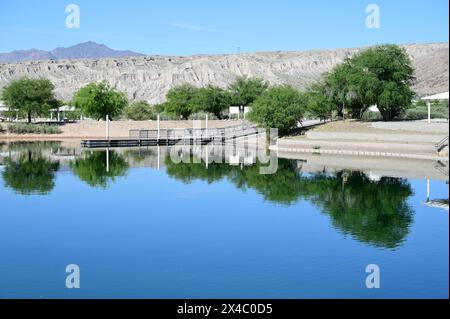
xmin=191 ymin=85 xmax=231 ymax=119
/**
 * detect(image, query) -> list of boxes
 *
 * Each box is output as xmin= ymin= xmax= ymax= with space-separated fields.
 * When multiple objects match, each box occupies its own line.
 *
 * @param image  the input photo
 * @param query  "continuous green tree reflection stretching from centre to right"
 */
xmin=165 ymin=158 xmax=413 ymax=248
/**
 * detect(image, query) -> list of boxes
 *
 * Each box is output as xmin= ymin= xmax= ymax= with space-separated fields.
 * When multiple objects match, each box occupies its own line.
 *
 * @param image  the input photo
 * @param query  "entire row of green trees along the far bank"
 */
xmin=1 ymin=45 xmax=414 ymax=134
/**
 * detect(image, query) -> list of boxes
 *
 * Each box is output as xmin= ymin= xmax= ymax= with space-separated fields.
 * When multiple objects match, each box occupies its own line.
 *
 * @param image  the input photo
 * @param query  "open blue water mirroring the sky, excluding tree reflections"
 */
xmin=0 ymin=145 xmax=449 ymax=298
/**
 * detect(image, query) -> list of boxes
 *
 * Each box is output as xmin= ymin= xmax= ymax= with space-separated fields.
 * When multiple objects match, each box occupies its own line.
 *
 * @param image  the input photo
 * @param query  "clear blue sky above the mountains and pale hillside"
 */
xmin=0 ymin=0 xmax=449 ymax=55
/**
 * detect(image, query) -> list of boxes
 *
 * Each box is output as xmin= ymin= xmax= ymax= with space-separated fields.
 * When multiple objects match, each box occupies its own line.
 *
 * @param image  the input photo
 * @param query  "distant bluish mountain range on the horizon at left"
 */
xmin=0 ymin=41 xmax=143 ymax=63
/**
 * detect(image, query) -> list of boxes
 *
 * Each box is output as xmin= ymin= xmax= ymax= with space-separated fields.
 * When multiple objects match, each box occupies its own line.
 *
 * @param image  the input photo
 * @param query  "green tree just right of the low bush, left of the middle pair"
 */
xmin=164 ymin=84 xmax=198 ymax=119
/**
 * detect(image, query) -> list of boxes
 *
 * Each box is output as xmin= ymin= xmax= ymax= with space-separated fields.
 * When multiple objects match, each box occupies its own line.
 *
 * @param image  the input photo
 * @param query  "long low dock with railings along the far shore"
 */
xmin=81 ymin=125 xmax=258 ymax=148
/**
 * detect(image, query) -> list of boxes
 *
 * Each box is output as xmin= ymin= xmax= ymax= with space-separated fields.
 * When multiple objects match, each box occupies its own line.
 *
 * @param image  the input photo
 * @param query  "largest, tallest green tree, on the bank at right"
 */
xmin=324 ymin=44 xmax=414 ymax=121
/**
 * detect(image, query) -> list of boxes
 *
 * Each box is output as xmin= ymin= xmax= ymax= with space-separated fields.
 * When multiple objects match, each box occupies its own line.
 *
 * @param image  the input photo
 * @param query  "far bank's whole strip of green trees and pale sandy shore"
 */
xmin=0 ymin=44 xmax=448 ymax=158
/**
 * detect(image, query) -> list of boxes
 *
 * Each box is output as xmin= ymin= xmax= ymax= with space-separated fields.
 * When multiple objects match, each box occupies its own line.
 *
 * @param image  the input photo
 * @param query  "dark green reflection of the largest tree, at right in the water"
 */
xmin=303 ymin=172 xmax=413 ymax=248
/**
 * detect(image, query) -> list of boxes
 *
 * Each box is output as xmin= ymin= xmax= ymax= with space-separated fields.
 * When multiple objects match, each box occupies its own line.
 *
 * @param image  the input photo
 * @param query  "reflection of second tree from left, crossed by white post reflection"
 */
xmin=70 ymin=151 xmax=128 ymax=188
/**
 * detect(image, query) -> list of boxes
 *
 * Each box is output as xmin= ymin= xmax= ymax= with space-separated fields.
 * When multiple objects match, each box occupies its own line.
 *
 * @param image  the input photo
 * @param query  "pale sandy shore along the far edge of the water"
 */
xmin=0 ymin=120 xmax=449 ymax=162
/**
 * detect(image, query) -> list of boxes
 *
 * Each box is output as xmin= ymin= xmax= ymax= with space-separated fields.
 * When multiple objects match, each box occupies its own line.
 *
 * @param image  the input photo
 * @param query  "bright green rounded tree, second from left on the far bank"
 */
xmin=72 ymin=81 xmax=128 ymax=120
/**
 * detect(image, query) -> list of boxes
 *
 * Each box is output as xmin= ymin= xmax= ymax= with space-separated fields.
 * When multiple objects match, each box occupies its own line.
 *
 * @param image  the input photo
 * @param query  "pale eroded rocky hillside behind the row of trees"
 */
xmin=0 ymin=43 xmax=449 ymax=103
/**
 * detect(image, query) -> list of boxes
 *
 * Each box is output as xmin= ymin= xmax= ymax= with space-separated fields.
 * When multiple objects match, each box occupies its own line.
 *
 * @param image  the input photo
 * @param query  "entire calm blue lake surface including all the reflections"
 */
xmin=0 ymin=142 xmax=449 ymax=298
